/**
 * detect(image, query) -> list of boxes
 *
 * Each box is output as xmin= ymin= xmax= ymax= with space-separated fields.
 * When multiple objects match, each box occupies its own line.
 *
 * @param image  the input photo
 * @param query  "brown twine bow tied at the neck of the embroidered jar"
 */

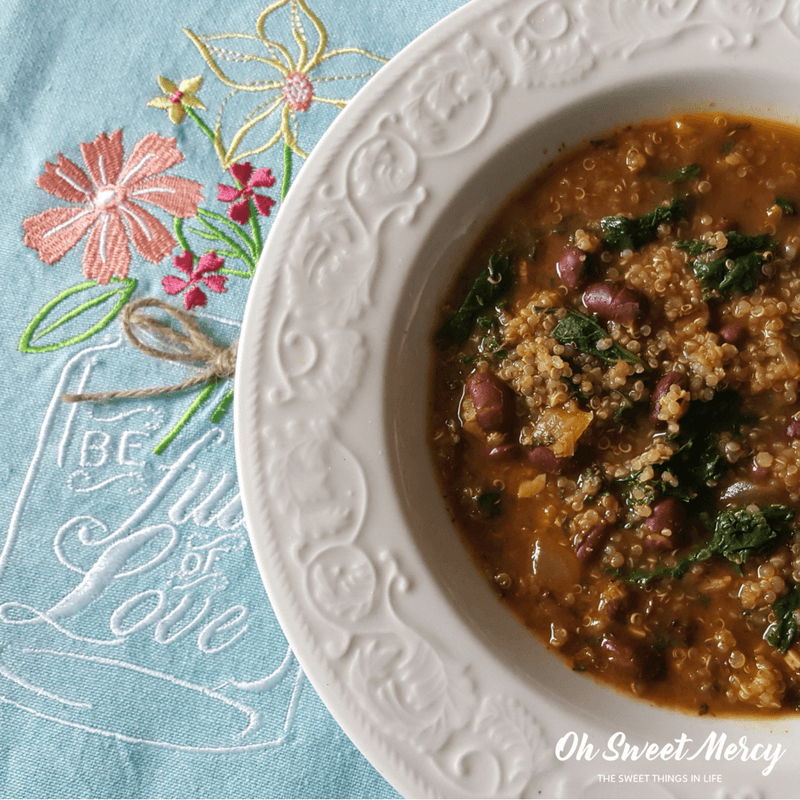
xmin=61 ymin=297 xmax=236 ymax=403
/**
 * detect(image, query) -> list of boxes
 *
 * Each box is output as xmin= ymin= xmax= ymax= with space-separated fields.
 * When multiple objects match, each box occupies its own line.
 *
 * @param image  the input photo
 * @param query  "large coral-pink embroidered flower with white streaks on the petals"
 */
xmin=22 ymin=131 xmax=203 ymax=283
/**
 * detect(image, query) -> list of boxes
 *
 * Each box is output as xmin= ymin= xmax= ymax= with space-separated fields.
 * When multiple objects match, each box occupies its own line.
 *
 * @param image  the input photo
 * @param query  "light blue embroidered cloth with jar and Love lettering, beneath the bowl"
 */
xmin=0 ymin=0 xmax=463 ymax=797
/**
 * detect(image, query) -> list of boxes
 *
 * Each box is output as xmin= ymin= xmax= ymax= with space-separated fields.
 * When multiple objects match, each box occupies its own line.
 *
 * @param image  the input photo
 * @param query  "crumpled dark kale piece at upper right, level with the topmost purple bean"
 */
xmin=689 ymin=231 xmax=775 ymax=296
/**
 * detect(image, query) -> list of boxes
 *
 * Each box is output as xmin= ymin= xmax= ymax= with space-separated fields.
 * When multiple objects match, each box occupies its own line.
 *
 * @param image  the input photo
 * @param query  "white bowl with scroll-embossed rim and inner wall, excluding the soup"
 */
xmin=235 ymin=0 xmax=800 ymax=796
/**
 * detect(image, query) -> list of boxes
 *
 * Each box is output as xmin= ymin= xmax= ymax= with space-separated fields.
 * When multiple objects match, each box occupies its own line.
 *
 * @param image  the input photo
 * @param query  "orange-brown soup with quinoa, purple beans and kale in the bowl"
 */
xmin=428 ymin=115 xmax=800 ymax=714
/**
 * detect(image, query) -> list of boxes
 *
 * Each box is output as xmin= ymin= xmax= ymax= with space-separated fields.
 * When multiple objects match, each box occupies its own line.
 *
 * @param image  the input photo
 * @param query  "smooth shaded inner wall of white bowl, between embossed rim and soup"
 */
xmin=384 ymin=71 xmax=800 ymax=735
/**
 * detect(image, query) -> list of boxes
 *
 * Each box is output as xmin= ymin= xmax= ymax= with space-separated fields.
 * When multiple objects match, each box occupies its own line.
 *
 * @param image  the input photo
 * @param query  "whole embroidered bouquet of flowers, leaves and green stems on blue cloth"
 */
xmin=18 ymin=0 xmax=387 ymax=453
